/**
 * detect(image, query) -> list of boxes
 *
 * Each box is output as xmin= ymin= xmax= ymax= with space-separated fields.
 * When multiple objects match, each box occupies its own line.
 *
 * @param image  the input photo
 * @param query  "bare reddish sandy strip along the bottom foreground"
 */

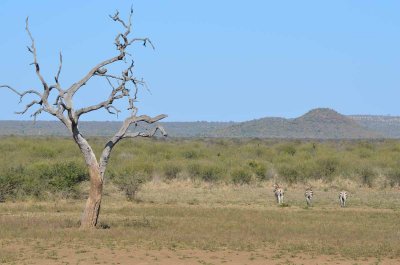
xmin=3 ymin=245 xmax=400 ymax=265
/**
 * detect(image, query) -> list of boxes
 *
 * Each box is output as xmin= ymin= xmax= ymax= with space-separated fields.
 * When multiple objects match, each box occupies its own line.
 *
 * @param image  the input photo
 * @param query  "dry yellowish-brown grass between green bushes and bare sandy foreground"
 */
xmin=0 ymin=181 xmax=400 ymax=264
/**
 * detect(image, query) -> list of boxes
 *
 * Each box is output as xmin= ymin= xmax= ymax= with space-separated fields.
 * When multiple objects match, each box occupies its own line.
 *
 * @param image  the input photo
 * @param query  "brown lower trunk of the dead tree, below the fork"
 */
xmin=81 ymin=163 xmax=103 ymax=229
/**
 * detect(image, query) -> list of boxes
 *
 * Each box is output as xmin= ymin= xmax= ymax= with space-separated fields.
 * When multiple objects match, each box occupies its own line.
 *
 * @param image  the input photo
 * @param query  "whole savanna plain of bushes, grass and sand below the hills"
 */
xmin=0 ymin=137 xmax=400 ymax=264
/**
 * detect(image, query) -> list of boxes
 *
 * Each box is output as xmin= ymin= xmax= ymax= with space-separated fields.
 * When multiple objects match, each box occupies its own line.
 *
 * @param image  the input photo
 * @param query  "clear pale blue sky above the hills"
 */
xmin=0 ymin=0 xmax=400 ymax=121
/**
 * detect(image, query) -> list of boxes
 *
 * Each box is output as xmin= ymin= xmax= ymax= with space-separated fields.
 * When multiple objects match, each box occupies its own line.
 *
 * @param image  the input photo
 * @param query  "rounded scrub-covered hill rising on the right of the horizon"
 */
xmin=215 ymin=108 xmax=384 ymax=139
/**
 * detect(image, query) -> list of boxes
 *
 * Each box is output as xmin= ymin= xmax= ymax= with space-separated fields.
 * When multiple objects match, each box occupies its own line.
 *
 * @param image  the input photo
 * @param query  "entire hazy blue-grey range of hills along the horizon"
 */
xmin=0 ymin=108 xmax=400 ymax=139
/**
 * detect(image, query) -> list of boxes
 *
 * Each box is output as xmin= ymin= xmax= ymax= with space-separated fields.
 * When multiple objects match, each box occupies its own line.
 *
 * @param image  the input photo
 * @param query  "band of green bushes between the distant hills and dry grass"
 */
xmin=0 ymin=137 xmax=400 ymax=200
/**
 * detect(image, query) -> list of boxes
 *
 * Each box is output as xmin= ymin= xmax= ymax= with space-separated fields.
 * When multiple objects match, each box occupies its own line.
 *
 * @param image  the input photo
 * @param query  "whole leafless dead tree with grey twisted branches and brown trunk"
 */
xmin=0 ymin=8 xmax=167 ymax=228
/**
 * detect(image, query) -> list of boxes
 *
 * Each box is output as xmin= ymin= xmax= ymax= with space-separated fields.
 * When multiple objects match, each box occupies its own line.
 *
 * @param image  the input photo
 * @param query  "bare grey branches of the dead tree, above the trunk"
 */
xmin=0 ymin=9 xmax=167 ymax=171
